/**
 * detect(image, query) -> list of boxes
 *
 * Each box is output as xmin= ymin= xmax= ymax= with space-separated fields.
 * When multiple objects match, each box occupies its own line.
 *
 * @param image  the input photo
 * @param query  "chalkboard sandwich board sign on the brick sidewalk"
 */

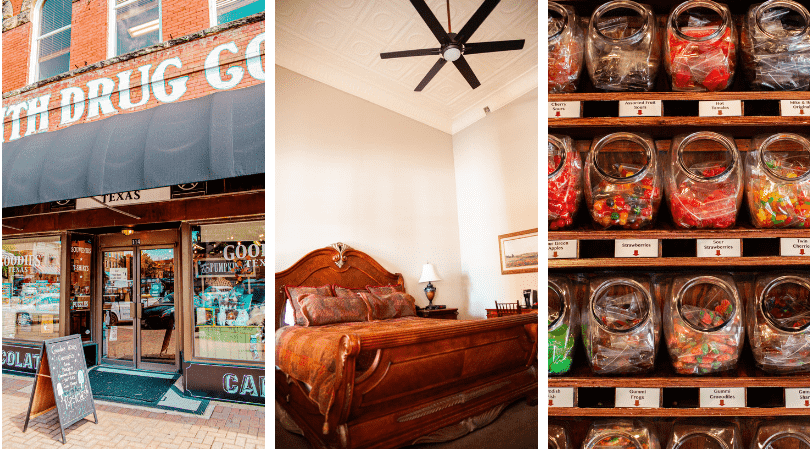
xmin=23 ymin=334 xmax=98 ymax=444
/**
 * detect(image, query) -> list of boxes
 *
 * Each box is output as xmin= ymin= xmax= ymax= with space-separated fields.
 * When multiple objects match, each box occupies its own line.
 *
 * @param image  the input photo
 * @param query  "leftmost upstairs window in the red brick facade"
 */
xmin=34 ymin=0 xmax=73 ymax=81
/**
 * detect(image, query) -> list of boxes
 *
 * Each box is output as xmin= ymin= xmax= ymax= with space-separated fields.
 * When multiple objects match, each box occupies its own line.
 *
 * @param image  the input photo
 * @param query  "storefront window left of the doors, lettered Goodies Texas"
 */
xmin=2 ymin=237 xmax=62 ymax=341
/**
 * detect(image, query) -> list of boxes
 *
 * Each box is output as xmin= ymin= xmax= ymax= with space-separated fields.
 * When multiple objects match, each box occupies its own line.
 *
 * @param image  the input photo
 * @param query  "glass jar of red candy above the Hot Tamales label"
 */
xmin=664 ymin=0 xmax=737 ymax=91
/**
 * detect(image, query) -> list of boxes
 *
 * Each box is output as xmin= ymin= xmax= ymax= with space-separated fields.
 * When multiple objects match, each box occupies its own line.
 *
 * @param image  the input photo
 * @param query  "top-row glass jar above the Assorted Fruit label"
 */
xmin=585 ymin=0 xmax=661 ymax=91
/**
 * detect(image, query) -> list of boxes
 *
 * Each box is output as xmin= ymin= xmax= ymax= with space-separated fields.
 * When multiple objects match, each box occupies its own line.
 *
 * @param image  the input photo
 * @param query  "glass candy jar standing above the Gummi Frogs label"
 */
xmin=582 ymin=277 xmax=661 ymax=374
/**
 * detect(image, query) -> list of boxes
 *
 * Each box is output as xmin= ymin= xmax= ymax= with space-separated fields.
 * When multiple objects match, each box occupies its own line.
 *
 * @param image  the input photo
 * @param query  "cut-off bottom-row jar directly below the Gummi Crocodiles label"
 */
xmin=667 ymin=419 xmax=745 ymax=448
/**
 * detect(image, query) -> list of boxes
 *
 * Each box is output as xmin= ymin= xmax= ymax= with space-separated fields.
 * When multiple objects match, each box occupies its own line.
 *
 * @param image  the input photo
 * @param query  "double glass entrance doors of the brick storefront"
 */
xmin=101 ymin=246 xmax=177 ymax=371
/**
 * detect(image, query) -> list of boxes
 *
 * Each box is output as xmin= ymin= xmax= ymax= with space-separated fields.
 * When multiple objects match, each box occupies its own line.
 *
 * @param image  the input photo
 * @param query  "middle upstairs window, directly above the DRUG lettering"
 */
xmin=111 ymin=0 xmax=162 ymax=56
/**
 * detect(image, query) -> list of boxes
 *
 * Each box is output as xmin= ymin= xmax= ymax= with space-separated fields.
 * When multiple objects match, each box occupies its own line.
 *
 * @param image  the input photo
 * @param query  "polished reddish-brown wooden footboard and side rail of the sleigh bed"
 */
xmin=276 ymin=314 xmax=538 ymax=448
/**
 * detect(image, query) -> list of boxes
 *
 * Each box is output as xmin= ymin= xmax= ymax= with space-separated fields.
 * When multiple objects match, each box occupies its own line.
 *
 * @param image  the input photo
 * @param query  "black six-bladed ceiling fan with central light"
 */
xmin=380 ymin=0 xmax=525 ymax=91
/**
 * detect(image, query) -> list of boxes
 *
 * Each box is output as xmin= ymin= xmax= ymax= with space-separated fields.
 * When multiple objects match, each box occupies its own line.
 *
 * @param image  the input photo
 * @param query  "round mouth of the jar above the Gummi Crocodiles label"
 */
xmin=675 ymin=276 xmax=739 ymax=333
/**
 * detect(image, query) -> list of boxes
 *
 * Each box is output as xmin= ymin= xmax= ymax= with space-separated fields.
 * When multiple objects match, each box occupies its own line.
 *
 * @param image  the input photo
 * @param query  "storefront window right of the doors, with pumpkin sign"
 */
xmin=192 ymin=221 xmax=265 ymax=362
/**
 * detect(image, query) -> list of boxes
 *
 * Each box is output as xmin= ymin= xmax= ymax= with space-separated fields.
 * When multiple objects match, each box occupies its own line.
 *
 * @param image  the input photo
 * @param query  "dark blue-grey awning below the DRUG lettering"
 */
xmin=3 ymin=84 xmax=264 ymax=208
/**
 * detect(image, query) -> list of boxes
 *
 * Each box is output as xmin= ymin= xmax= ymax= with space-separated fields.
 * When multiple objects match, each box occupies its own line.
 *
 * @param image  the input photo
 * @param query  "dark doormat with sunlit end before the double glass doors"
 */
xmin=87 ymin=366 xmax=209 ymax=415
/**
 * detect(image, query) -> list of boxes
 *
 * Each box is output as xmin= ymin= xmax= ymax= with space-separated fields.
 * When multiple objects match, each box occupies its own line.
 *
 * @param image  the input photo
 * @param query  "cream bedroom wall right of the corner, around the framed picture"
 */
xmin=453 ymin=89 xmax=539 ymax=317
